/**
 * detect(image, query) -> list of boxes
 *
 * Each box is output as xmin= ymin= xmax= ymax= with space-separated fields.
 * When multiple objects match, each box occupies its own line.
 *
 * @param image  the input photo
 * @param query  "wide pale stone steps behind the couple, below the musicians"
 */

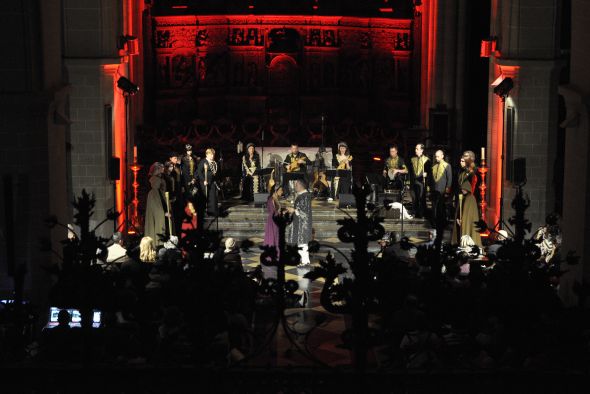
xmin=206 ymin=200 xmax=430 ymax=244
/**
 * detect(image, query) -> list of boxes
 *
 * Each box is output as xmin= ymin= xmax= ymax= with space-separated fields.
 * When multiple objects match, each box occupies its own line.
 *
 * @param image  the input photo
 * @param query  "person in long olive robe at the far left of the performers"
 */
xmin=144 ymin=162 xmax=167 ymax=246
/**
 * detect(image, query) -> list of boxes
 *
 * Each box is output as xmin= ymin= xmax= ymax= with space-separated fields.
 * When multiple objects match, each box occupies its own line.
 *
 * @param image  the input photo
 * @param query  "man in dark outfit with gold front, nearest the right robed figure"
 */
xmin=432 ymin=149 xmax=453 ymax=229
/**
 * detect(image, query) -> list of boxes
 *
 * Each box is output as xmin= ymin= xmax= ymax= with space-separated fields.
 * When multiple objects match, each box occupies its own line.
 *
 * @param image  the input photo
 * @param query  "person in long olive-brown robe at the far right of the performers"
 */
xmin=451 ymin=154 xmax=482 ymax=247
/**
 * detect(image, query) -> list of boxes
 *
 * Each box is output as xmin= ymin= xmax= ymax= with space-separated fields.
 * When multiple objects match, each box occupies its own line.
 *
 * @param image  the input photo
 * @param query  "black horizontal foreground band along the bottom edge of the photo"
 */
xmin=0 ymin=365 xmax=590 ymax=394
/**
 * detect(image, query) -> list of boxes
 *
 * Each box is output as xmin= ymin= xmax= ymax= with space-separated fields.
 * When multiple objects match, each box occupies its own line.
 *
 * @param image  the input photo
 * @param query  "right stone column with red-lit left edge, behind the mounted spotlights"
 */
xmin=488 ymin=0 xmax=561 ymax=231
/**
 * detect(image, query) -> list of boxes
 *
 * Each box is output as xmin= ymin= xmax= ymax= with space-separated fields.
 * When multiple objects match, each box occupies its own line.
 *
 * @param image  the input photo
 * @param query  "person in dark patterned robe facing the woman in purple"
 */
xmin=286 ymin=179 xmax=313 ymax=265
